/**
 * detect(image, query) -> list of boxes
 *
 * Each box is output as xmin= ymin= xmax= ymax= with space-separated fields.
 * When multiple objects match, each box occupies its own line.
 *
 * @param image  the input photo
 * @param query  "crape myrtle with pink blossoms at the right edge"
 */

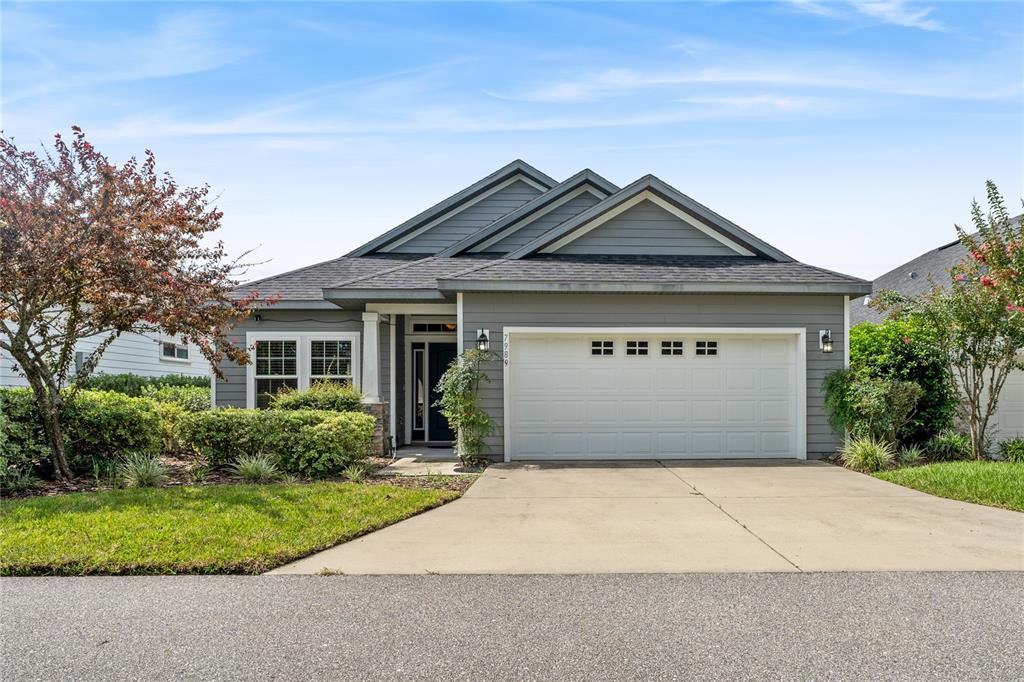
xmin=871 ymin=182 xmax=1024 ymax=459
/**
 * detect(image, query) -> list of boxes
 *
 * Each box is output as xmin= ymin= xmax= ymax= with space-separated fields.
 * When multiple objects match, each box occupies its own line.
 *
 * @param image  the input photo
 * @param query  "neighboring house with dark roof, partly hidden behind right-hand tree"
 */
xmin=850 ymin=231 xmax=1024 ymax=439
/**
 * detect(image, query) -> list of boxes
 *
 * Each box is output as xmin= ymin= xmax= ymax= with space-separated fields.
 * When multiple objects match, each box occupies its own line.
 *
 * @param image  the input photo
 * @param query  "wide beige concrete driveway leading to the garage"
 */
xmin=272 ymin=461 xmax=1024 ymax=573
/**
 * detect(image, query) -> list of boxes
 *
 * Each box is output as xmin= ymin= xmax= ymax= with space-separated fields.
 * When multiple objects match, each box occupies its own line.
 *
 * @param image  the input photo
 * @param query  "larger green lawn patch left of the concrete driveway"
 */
xmin=0 ymin=482 xmax=459 ymax=576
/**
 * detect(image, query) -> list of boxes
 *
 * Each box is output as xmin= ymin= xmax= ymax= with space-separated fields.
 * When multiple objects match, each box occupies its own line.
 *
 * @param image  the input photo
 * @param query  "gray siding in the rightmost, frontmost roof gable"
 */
xmin=558 ymin=201 xmax=736 ymax=256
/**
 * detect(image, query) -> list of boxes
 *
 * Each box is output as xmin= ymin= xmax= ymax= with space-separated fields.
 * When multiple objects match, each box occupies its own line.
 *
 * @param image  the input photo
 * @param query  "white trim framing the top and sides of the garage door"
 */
xmin=502 ymin=327 xmax=807 ymax=462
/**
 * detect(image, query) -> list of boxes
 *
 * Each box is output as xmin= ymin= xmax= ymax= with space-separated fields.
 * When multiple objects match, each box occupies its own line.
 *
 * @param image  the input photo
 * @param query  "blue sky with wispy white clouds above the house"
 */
xmin=0 ymin=0 xmax=1024 ymax=278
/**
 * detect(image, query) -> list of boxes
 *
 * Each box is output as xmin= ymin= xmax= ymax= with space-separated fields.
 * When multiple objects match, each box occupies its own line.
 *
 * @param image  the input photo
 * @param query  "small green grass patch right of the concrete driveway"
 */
xmin=872 ymin=462 xmax=1024 ymax=511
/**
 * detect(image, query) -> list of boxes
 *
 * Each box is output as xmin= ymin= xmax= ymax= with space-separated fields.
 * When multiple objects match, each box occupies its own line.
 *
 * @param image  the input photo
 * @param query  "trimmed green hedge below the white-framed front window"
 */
xmin=178 ymin=408 xmax=376 ymax=476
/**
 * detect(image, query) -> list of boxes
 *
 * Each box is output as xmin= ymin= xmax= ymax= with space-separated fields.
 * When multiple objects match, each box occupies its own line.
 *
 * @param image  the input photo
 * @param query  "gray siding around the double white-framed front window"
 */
xmin=217 ymin=308 xmax=362 ymax=408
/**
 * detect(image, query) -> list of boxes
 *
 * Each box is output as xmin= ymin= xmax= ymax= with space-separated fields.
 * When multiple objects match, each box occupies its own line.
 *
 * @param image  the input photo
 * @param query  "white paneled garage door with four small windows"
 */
xmin=508 ymin=334 xmax=801 ymax=459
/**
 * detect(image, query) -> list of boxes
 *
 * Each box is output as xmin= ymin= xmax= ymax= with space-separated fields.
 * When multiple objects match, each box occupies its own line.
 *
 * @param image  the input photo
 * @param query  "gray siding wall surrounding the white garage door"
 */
xmin=461 ymin=293 xmax=846 ymax=457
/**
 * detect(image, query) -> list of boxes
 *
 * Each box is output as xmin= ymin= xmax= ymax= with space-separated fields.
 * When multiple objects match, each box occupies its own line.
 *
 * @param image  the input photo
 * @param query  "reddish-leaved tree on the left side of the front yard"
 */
xmin=0 ymin=127 xmax=272 ymax=479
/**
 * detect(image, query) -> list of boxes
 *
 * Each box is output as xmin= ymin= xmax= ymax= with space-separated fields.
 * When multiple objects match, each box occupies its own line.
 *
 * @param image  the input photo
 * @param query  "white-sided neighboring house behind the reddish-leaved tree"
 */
xmin=0 ymin=334 xmax=210 ymax=386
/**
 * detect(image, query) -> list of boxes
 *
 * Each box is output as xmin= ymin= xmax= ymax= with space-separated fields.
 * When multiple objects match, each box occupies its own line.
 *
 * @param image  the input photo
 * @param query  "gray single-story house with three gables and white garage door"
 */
xmin=224 ymin=161 xmax=870 ymax=460
